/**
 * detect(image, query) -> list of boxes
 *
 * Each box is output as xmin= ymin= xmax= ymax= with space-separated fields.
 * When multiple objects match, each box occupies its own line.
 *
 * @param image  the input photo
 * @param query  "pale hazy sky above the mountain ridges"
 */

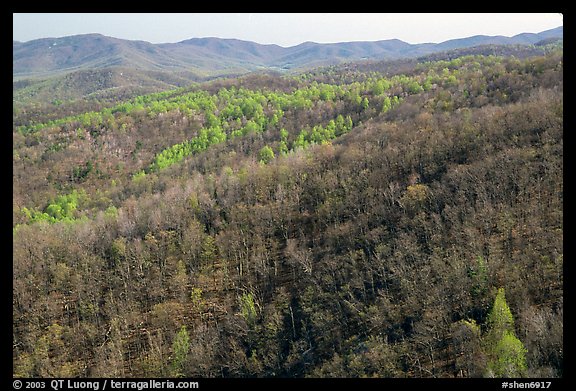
xmin=13 ymin=13 xmax=563 ymax=46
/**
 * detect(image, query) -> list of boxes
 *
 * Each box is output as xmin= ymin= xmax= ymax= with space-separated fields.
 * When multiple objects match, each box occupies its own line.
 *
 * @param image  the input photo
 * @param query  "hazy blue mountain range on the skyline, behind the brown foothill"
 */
xmin=12 ymin=26 xmax=564 ymax=79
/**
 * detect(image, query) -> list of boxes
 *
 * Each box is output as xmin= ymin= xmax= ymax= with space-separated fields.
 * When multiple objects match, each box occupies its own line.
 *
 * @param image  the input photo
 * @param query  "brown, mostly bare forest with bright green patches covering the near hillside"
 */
xmin=12 ymin=45 xmax=564 ymax=378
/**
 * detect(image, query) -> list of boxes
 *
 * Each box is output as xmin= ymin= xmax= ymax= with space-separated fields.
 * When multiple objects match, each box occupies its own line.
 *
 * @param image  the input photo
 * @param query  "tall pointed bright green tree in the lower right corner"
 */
xmin=485 ymin=288 xmax=527 ymax=377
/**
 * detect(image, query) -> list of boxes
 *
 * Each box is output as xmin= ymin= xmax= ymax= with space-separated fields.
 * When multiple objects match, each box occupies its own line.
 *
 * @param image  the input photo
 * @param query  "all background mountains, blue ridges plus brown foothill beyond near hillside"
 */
xmin=12 ymin=27 xmax=563 ymax=106
